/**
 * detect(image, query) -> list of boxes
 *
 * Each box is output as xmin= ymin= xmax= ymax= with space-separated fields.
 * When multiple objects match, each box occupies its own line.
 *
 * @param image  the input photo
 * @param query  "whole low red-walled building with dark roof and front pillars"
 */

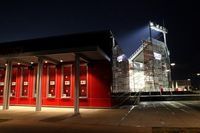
xmin=0 ymin=31 xmax=129 ymax=113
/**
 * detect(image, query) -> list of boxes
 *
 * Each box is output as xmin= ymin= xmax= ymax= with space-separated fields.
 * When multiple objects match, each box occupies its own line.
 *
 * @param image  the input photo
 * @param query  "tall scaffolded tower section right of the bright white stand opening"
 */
xmin=143 ymin=39 xmax=170 ymax=91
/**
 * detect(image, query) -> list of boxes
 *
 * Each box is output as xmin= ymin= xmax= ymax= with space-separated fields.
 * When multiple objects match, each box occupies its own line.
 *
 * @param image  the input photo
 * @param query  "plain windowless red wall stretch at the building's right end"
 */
xmin=85 ymin=62 xmax=112 ymax=107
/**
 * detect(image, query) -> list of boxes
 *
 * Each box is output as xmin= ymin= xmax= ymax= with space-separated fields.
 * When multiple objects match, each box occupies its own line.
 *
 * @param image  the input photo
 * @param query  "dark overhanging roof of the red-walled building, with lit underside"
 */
xmin=0 ymin=31 xmax=112 ymax=64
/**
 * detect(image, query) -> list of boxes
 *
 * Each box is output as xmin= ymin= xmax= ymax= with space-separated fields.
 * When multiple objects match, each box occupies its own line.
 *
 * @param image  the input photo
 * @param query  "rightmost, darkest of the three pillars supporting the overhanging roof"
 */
xmin=74 ymin=54 xmax=80 ymax=115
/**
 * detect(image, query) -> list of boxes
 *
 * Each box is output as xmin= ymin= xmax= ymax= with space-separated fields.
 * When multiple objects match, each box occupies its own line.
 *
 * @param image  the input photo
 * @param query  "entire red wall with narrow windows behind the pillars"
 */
xmin=0 ymin=61 xmax=112 ymax=107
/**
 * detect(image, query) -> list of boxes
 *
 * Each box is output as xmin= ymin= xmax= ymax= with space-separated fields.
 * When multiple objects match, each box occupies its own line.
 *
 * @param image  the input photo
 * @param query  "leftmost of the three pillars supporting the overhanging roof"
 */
xmin=3 ymin=60 xmax=12 ymax=110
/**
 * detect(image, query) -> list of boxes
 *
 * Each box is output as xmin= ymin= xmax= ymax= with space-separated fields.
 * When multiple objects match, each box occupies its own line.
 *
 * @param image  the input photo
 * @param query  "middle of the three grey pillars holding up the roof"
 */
xmin=36 ymin=57 xmax=43 ymax=111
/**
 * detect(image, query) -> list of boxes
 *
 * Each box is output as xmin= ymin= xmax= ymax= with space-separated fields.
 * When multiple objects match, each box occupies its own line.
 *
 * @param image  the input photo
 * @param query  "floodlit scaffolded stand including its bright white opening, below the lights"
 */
xmin=129 ymin=39 xmax=170 ymax=92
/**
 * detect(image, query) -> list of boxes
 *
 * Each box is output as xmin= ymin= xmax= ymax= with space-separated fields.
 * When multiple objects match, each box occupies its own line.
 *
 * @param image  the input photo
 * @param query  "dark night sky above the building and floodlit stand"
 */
xmin=0 ymin=0 xmax=200 ymax=79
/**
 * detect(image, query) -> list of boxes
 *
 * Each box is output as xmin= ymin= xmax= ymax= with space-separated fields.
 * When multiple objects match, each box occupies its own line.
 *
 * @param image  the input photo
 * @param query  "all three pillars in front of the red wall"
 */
xmin=3 ymin=54 xmax=80 ymax=115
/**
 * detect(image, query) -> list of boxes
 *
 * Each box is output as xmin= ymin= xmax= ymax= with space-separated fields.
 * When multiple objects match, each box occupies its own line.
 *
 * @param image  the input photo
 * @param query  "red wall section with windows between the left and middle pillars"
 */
xmin=10 ymin=66 xmax=36 ymax=105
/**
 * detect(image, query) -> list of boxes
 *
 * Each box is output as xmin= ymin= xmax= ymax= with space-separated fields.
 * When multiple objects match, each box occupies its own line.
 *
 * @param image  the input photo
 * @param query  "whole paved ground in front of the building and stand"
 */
xmin=0 ymin=101 xmax=200 ymax=133
